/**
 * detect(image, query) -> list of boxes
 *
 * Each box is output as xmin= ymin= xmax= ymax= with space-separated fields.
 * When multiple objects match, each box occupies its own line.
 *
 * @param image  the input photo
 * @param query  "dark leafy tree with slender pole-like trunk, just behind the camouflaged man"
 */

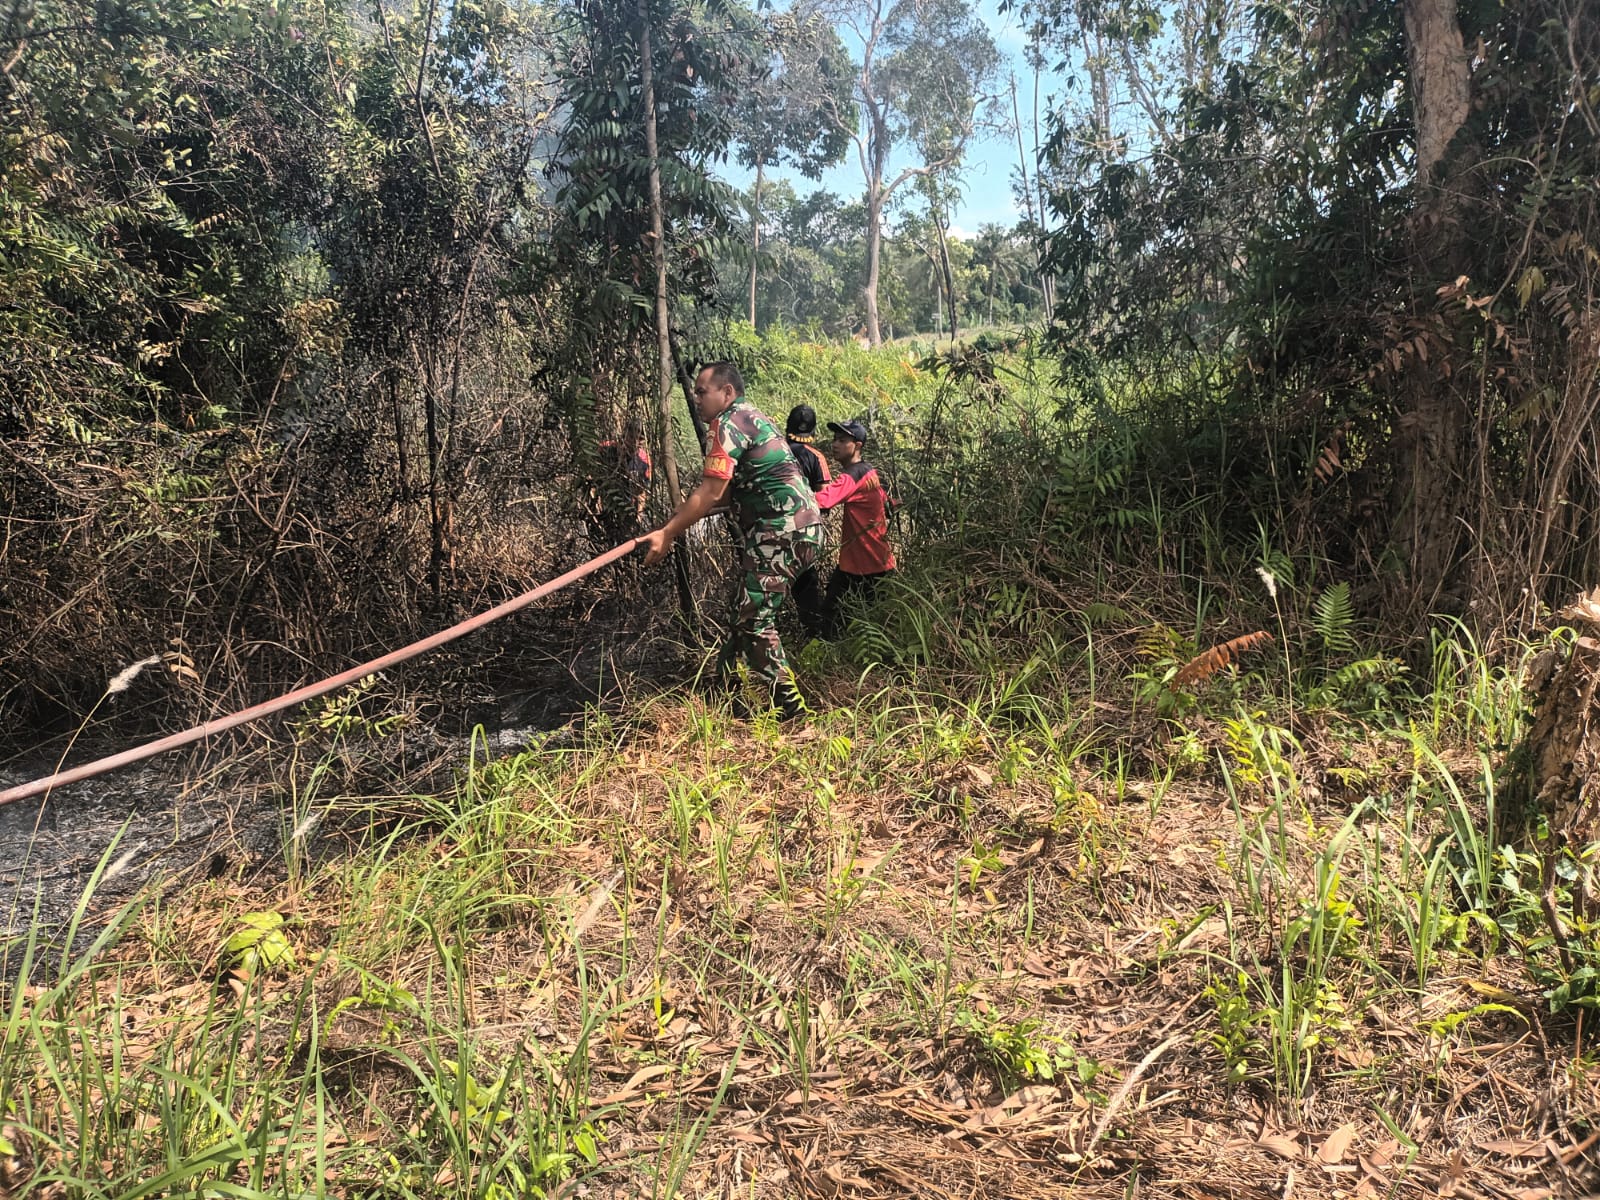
xmin=542 ymin=0 xmax=760 ymax=491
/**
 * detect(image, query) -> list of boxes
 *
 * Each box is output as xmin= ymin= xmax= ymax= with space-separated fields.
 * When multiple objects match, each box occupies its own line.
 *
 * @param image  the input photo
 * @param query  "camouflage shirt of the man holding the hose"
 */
xmin=706 ymin=400 xmax=822 ymax=534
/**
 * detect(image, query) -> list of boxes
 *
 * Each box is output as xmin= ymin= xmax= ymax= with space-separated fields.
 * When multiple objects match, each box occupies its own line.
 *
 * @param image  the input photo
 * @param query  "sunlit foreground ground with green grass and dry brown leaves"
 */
xmin=0 ymin=435 xmax=1592 ymax=1200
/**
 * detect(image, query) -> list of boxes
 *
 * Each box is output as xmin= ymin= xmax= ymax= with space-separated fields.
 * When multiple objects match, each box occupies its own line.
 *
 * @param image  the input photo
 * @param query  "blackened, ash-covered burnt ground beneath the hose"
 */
xmin=0 ymin=573 xmax=720 ymax=976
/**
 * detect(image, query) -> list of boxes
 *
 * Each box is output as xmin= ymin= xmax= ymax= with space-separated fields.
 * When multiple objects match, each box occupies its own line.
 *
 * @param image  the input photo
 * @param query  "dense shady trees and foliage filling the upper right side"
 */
xmin=1022 ymin=0 xmax=1600 ymax=624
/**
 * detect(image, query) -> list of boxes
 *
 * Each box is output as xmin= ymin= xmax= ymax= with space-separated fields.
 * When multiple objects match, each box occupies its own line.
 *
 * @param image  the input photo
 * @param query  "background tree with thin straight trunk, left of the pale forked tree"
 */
xmin=734 ymin=11 xmax=854 ymax=325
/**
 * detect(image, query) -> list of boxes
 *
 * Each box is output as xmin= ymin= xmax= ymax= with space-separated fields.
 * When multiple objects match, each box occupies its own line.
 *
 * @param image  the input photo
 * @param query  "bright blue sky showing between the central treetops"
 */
xmin=723 ymin=0 xmax=1064 ymax=235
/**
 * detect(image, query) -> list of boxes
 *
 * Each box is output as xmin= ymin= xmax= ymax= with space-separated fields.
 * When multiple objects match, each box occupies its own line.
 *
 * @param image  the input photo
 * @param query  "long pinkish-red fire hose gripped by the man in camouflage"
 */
xmin=0 ymin=538 xmax=638 ymax=808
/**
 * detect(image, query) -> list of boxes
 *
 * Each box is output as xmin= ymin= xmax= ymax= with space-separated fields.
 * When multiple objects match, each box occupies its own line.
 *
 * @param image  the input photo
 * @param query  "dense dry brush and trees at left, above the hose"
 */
xmin=0 ymin=0 xmax=566 ymax=729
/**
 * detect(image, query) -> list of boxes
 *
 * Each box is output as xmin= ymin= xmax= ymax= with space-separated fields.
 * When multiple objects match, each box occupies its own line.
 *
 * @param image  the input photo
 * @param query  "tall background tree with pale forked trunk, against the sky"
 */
xmin=811 ymin=0 xmax=1000 ymax=346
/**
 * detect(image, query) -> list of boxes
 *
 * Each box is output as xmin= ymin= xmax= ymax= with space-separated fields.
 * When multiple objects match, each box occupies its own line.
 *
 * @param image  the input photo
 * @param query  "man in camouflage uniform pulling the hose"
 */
xmin=640 ymin=363 xmax=822 ymax=720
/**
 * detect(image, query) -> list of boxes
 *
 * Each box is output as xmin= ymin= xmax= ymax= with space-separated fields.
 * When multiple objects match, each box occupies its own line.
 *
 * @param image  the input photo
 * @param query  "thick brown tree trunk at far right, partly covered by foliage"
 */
xmin=1395 ymin=0 xmax=1472 ymax=611
